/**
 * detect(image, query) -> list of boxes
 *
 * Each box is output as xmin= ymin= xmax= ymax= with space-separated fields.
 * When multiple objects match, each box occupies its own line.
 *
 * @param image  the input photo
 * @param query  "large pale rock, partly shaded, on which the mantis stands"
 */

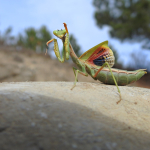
xmin=0 ymin=82 xmax=150 ymax=150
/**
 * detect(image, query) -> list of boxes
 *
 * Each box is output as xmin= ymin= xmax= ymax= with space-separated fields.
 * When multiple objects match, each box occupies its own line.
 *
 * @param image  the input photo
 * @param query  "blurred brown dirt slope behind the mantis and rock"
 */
xmin=0 ymin=47 xmax=150 ymax=88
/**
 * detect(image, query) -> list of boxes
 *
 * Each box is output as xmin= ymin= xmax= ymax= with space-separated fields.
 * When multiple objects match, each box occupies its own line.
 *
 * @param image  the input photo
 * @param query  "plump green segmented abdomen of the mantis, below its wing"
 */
xmin=95 ymin=68 xmax=146 ymax=85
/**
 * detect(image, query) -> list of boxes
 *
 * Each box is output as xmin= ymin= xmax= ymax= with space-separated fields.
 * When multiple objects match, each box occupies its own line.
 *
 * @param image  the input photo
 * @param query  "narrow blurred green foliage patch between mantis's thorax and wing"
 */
xmin=69 ymin=34 xmax=81 ymax=57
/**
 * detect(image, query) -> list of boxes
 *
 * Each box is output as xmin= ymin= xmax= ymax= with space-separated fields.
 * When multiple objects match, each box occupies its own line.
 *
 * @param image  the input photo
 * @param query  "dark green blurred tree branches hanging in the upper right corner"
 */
xmin=93 ymin=0 xmax=150 ymax=49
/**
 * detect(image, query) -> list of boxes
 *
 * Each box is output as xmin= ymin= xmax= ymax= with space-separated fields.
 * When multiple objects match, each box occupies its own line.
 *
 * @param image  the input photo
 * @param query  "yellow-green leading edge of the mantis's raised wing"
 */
xmin=79 ymin=41 xmax=109 ymax=60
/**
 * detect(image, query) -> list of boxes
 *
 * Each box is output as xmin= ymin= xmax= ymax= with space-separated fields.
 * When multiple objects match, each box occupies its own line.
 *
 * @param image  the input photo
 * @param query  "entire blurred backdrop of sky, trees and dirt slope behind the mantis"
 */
xmin=0 ymin=0 xmax=150 ymax=88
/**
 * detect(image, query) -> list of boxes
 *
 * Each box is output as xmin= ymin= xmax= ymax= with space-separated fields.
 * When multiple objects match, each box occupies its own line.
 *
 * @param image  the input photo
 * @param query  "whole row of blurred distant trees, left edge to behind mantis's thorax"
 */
xmin=0 ymin=26 xmax=81 ymax=56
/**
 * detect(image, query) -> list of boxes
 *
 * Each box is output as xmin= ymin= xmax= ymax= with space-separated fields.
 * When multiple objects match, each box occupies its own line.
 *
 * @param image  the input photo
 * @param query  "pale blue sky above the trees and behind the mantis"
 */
xmin=0 ymin=0 xmax=150 ymax=70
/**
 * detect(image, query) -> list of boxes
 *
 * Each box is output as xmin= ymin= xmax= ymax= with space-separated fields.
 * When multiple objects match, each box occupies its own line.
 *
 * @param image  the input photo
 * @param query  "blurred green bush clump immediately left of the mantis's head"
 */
xmin=17 ymin=26 xmax=52 ymax=51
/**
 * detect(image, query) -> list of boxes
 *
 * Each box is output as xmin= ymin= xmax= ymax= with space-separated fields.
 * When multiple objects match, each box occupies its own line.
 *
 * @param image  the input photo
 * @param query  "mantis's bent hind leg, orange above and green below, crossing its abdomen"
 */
xmin=93 ymin=62 xmax=121 ymax=104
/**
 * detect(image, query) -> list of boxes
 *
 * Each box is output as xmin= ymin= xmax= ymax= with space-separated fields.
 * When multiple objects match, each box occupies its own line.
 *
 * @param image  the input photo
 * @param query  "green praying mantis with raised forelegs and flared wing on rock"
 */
xmin=46 ymin=23 xmax=147 ymax=104
